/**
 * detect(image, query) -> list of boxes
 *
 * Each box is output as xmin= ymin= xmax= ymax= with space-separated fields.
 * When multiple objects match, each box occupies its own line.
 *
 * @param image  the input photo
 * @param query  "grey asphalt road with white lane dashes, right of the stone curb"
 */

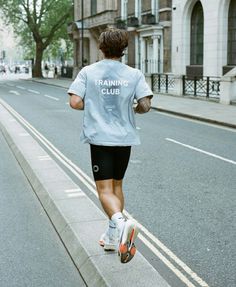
xmin=0 ymin=77 xmax=236 ymax=287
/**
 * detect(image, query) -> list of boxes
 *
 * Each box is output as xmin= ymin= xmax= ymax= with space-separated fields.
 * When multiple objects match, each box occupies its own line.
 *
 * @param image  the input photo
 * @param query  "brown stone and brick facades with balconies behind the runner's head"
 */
xmin=68 ymin=0 xmax=172 ymax=75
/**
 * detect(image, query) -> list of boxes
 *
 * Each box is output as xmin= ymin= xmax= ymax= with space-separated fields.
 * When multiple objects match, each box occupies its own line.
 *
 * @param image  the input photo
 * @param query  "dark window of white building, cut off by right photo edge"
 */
xmin=228 ymin=0 xmax=236 ymax=66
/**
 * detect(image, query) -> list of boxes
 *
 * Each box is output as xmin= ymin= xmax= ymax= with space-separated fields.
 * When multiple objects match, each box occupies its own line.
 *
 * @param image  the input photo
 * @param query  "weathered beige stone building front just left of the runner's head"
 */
xmin=68 ymin=0 xmax=117 ymax=77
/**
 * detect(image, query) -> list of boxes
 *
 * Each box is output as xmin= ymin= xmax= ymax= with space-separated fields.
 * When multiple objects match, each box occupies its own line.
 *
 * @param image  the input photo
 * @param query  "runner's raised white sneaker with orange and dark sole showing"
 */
xmin=118 ymin=219 xmax=139 ymax=263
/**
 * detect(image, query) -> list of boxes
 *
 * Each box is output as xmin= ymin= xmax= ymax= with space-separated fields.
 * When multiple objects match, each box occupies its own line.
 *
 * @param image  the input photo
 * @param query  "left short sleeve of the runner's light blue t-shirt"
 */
xmin=67 ymin=68 xmax=87 ymax=99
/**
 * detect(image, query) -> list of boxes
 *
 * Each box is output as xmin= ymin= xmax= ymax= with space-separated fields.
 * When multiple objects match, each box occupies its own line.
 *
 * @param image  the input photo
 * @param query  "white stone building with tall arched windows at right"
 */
xmin=172 ymin=0 xmax=236 ymax=103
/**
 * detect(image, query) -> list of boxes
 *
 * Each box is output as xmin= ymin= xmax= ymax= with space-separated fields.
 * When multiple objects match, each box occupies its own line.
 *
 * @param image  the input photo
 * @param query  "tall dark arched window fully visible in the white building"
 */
xmin=190 ymin=1 xmax=204 ymax=65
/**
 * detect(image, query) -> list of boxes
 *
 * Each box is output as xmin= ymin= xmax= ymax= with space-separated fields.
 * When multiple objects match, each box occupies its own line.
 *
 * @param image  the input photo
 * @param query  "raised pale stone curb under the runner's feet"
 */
xmin=0 ymin=102 xmax=169 ymax=287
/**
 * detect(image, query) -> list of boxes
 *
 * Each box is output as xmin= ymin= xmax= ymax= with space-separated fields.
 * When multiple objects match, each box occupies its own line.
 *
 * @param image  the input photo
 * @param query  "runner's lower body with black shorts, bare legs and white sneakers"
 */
xmin=91 ymin=145 xmax=138 ymax=263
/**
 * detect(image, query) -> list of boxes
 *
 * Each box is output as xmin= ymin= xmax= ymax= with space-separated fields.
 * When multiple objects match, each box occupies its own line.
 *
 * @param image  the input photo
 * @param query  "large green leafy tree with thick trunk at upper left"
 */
xmin=0 ymin=0 xmax=73 ymax=77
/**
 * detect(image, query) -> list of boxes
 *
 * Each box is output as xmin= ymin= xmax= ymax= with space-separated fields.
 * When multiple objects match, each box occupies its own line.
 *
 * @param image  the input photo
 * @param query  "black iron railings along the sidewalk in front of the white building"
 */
xmin=151 ymin=74 xmax=220 ymax=99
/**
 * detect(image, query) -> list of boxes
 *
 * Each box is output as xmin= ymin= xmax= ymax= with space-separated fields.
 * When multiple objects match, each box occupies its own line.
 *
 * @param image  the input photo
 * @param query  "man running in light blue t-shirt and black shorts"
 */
xmin=68 ymin=29 xmax=153 ymax=263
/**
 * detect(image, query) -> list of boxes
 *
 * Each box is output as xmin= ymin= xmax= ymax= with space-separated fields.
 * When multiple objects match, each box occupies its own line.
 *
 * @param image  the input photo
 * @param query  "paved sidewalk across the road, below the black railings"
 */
xmin=30 ymin=78 xmax=236 ymax=128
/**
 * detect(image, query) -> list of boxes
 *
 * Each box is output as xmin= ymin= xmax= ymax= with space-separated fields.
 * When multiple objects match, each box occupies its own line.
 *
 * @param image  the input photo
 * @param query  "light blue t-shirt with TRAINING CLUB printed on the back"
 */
xmin=68 ymin=59 xmax=153 ymax=146
